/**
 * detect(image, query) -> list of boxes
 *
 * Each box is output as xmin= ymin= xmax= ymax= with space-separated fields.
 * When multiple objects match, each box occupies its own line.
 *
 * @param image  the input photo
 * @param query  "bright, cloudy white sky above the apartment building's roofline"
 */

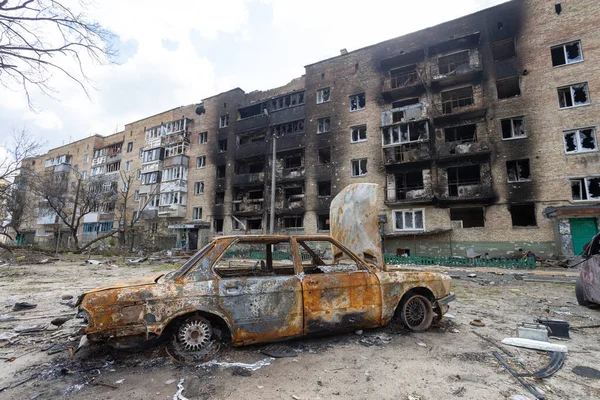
xmin=0 ymin=0 xmax=505 ymax=153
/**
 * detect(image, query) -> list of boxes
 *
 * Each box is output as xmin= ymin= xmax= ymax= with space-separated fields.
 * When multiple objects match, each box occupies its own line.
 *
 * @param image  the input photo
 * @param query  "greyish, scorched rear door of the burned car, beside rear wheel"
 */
xmin=214 ymin=238 xmax=303 ymax=344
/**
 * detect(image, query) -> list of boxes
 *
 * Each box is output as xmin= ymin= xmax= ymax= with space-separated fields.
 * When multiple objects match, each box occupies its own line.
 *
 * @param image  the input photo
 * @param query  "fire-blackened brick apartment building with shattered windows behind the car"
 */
xmin=16 ymin=0 xmax=600 ymax=257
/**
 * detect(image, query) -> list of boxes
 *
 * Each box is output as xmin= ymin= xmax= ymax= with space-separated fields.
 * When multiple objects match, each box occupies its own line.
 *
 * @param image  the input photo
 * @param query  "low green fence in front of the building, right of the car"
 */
xmin=384 ymin=254 xmax=535 ymax=269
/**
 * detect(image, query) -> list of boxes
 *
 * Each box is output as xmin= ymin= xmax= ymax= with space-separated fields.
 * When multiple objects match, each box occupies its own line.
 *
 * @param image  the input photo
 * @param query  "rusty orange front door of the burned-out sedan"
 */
xmin=298 ymin=238 xmax=381 ymax=334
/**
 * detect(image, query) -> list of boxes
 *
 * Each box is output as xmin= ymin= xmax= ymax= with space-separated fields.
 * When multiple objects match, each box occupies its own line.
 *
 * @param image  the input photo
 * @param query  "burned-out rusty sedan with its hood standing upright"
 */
xmin=78 ymin=185 xmax=454 ymax=351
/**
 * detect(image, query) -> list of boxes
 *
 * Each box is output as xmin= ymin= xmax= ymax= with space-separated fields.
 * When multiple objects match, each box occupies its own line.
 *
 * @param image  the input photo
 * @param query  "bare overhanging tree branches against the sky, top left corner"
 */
xmin=0 ymin=0 xmax=116 ymax=109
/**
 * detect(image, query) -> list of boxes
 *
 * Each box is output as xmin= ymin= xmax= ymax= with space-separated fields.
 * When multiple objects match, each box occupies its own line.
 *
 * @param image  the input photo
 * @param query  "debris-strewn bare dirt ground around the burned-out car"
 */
xmin=0 ymin=256 xmax=600 ymax=400
